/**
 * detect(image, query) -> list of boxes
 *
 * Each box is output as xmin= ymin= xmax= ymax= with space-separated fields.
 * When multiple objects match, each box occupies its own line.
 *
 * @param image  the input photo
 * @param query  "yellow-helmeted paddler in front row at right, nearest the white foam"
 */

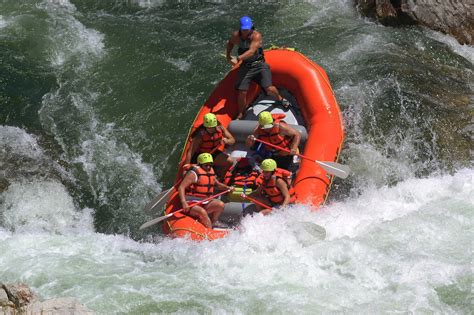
xmin=249 ymin=159 xmax=296 ymax=215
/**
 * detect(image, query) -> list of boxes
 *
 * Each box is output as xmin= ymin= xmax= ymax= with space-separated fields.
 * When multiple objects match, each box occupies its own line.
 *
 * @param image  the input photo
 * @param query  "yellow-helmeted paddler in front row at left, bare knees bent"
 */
xmin=178 ymin=153 xmax=234 ymax=228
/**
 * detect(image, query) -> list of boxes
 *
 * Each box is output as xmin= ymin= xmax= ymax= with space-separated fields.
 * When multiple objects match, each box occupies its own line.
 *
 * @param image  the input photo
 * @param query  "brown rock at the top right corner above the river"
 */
xmin=355 ymin=0 xmax=474 ymax=45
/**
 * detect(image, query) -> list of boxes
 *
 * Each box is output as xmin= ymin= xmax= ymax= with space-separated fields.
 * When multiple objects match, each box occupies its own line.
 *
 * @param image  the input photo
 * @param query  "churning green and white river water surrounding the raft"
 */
xmin=0 ymin=0 xmax=474 ymax=314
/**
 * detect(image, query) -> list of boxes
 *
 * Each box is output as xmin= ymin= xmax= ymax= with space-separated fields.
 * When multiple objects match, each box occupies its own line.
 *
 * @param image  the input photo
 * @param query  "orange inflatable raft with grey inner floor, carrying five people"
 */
xmin=162 ymin=48 xmax=344 ymax=240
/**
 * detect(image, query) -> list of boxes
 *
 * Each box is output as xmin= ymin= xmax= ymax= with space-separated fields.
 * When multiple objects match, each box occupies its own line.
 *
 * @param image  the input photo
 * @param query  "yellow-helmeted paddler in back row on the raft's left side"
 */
xmin=184 ymin=113 xmax=235 ymax=178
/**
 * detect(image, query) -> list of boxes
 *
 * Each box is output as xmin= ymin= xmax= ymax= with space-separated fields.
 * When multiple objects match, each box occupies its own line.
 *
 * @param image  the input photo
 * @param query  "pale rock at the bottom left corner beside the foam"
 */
xmin=0 ymin=283 xmax=94 ymax=315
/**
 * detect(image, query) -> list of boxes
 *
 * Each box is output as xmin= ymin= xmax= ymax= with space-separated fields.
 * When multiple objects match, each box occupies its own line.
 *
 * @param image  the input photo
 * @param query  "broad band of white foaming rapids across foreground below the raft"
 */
xmin=0 ymin=169 xmax=474 ymax=313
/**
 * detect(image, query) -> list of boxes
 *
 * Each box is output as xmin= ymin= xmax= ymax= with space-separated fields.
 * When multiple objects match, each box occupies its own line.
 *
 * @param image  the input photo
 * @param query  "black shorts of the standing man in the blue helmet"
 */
xmin=235 ymin=61 xmax=272 ymax=91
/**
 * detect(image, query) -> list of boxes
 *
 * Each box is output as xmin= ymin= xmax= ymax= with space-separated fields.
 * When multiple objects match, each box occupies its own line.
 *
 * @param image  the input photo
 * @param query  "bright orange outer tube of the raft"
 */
xmin=163 ymin=48 xmax=344 ymax=240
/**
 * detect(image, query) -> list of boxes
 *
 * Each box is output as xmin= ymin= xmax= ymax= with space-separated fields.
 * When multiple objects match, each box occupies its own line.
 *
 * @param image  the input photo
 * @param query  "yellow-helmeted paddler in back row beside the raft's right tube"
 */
xmin=247 ymin=111 xmax=301 ymax=171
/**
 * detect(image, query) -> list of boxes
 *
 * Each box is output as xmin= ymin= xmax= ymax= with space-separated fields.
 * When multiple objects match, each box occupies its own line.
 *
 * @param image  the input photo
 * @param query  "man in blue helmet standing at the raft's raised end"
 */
xmin=226 ymin=16 xmax=290 ymax=119
